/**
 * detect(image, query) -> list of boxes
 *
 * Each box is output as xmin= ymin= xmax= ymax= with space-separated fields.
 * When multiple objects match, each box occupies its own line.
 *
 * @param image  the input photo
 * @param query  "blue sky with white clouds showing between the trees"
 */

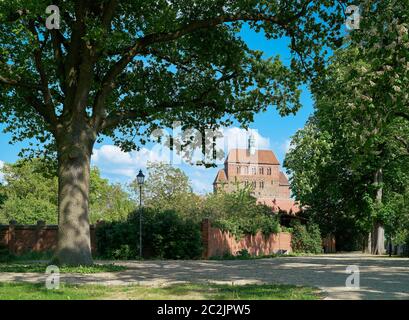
xmin=0 ymin=24 xmax=313 ymax=193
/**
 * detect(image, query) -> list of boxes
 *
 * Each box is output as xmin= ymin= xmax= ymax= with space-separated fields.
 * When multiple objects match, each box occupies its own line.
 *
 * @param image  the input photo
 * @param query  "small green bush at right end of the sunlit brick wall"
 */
xmin=291 ymin=221 xmax=322 ymax=253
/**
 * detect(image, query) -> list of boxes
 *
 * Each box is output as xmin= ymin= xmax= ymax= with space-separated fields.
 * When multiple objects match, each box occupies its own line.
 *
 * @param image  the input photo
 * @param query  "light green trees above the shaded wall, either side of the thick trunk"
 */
xmin=0 ymin=159 xmax=135 ymax=224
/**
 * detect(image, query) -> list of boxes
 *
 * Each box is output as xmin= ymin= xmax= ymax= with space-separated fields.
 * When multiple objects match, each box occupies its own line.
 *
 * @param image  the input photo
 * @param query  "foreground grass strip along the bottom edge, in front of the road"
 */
xmin=0 ymin=283 xmax=322 ymax=300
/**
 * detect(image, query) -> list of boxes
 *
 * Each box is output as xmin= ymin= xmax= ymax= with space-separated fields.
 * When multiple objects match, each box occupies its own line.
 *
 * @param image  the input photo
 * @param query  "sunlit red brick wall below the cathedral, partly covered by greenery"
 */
xmin=202 ymin=219 xmax=292 ymax=259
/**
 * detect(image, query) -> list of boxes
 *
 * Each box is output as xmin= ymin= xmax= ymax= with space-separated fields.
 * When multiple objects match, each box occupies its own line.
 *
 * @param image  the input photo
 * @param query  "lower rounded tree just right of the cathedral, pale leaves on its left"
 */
xmin=284 ymin=115 xmax=371 ymax=251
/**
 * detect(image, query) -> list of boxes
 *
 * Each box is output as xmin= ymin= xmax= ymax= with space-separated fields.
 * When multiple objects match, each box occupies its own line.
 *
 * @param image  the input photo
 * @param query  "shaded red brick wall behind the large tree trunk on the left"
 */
xmin=0 ymin=221 xmax=96 ymax=255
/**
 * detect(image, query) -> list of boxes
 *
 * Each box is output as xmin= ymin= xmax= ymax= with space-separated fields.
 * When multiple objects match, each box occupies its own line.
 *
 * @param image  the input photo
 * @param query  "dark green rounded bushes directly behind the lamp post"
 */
xmin=97 ymin=209 xmax=202 ymax=259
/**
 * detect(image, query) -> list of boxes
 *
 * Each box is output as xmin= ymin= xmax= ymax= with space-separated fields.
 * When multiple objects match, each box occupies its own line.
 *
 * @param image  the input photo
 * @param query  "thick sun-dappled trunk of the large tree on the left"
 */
xmin=56 ymin=124 xmax=95 ymax=265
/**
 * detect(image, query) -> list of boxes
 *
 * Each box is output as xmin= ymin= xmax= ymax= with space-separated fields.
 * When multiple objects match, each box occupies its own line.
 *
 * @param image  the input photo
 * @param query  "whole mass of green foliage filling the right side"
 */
xmin=285 ymin=0 xmax=409 ymax=245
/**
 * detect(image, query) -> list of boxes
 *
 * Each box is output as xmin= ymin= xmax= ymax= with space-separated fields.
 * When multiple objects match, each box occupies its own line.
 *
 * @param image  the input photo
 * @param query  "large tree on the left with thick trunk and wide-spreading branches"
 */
xmin=0 ymin=0 xmax=343 ymax=264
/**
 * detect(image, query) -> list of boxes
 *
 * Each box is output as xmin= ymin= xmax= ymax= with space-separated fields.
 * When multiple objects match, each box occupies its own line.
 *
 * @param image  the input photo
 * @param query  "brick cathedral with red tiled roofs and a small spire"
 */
xmin=213 ymin=135 xmax=299 ymax=214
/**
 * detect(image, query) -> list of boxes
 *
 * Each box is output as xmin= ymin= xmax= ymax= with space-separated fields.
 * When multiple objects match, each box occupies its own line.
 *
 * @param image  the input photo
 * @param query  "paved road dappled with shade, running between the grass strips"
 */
xmin=0 ymin=254 xmax=409 ymax=299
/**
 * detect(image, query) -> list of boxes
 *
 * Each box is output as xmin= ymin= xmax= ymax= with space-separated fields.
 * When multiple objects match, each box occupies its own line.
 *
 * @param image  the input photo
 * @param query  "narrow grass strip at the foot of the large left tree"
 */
xmin=0 ymin=262 xmax=127 ymax=273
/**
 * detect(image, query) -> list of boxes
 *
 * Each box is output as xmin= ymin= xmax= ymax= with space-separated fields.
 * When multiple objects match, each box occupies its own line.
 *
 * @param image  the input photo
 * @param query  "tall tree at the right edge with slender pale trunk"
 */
xmin=342 ymin=0 xmax=409 ymax=253
